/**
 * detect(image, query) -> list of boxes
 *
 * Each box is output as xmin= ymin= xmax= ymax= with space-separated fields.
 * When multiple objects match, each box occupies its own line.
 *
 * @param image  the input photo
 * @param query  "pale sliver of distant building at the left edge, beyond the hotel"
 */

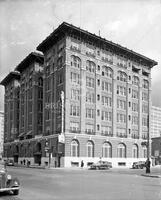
xmin=0 ymin=111 xmax=4 ymax=158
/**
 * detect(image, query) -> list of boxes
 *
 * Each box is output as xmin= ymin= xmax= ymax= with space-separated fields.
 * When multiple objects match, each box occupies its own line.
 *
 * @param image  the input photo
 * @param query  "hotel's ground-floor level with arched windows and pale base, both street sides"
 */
xmin=4 ymin=133 xmax=147 ymax=168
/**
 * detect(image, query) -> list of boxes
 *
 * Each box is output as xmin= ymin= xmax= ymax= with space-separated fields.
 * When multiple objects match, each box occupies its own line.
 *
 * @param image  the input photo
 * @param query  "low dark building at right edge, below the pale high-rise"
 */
xmin=151 ymin=137 xmax=161 ymax=165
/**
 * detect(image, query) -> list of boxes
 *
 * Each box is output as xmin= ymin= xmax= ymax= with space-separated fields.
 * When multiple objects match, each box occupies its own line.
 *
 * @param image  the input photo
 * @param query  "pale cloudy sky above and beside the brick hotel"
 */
xmin=0 ymin=0 xmax=161 ymax=110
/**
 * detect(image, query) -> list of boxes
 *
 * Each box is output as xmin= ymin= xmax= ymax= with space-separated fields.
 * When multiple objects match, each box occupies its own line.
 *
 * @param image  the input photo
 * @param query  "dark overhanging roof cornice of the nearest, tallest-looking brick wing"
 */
xmin=37 ymin=22 xmax=158 ymax=67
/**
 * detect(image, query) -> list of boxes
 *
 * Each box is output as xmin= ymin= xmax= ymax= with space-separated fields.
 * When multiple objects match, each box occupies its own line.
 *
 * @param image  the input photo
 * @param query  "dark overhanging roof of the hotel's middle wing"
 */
xmin=15 ymin=52 xmax=44 ymax=72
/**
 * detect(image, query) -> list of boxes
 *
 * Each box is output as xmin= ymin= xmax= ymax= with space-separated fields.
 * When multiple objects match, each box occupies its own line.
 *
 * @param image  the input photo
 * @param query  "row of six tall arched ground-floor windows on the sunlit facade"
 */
xmin=70 ymin=140 xmax=147 ymax=158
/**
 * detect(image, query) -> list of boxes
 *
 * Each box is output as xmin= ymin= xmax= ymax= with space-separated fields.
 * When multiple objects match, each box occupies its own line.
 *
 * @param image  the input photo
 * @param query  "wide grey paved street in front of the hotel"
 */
xmin=0 ymin=167 xmax=161 ymax=200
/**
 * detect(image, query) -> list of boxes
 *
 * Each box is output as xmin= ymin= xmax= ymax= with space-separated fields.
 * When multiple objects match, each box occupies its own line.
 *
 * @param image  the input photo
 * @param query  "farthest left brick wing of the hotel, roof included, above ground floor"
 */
xmin=1 ymin=72 xmax=20 ymax=144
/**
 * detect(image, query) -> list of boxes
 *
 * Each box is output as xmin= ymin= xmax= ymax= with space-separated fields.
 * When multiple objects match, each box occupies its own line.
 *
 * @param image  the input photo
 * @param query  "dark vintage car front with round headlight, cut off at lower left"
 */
xmin=0 ymin=161 xmax=20 ymax=195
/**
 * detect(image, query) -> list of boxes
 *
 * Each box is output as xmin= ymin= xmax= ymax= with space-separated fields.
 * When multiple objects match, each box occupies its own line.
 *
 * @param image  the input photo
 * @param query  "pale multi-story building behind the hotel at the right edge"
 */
xmin=150 ymin=106 xmax=161 ymax=138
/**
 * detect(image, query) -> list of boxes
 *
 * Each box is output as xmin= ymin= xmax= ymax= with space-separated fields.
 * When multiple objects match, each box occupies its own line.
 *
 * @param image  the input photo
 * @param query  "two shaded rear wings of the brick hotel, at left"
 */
xmin=1 ymin=53 xmax=44 ymax=165
